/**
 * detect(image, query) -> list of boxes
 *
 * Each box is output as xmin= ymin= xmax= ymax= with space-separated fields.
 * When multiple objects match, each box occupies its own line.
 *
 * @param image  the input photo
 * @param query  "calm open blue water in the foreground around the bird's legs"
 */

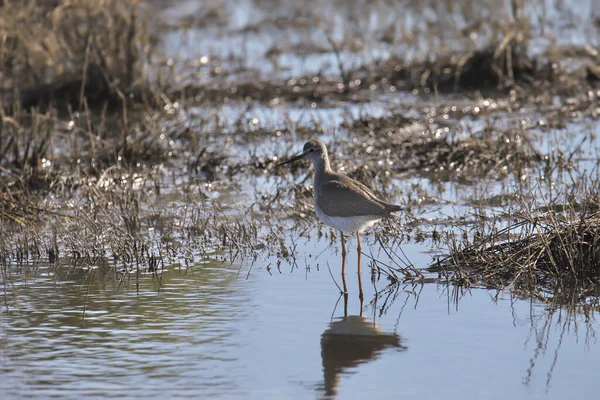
xmin=0 ymin=240 xmax=600 ymax=399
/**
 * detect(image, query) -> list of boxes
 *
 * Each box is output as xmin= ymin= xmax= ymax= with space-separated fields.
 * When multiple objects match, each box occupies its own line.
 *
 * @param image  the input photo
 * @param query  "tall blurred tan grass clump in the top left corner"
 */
xmin=0 ymin=0 xmax=151 ymax=111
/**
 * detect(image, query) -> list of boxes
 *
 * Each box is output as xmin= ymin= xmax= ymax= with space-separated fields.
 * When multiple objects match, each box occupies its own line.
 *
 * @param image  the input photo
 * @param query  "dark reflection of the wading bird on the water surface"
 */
xmin=318 ymin=278 xmax=406 ymax=398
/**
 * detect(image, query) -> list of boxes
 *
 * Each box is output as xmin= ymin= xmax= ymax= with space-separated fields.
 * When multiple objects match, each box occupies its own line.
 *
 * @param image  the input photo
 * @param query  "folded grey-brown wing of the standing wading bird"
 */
xmin=315 ymin=181 xmax=389 ymax=218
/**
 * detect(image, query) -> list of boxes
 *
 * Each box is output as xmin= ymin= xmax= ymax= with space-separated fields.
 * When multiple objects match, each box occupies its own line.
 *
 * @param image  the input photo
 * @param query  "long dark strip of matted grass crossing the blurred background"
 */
xmin=174 ymin=26 xmax=599 ymax=107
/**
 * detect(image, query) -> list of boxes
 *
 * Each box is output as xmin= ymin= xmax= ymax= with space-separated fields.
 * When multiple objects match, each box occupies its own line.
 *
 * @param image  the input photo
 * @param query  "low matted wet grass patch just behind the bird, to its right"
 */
xmin=346 ymin=115 xmax=542 ymax=181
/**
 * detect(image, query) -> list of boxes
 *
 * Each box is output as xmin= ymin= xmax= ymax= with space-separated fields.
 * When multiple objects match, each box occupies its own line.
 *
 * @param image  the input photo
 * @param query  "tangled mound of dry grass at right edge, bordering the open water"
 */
xmin=431 ymin=178 xmax=600 ymax=304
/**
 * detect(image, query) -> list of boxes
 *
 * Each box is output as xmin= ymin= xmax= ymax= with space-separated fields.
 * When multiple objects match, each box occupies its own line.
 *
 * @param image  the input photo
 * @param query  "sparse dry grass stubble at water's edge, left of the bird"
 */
xmin=0 ymin=170 xmax=268 ymax=273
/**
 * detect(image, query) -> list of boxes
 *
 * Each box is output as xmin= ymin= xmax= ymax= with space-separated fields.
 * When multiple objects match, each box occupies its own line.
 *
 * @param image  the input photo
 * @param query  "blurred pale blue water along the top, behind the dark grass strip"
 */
xmin=162 ymin=0 xmax=600 ymax=82
